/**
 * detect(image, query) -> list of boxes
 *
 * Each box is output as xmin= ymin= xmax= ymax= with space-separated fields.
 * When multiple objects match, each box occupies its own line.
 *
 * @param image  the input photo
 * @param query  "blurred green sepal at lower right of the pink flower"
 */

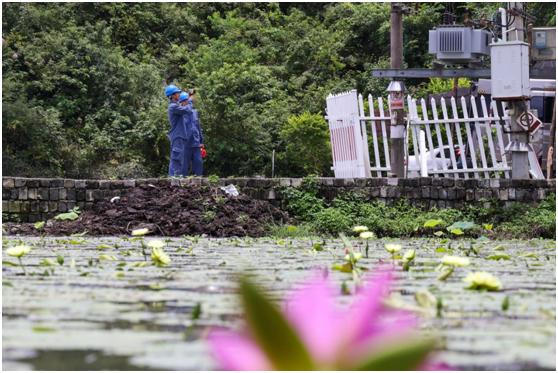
xmin=356 ymin=338 xmax=435 ymax=371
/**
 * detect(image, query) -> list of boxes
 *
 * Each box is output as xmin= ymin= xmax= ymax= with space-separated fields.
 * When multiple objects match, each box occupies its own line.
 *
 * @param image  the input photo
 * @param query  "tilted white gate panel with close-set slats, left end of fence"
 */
xmin=326 ymin=90 xmax=370 ymax=178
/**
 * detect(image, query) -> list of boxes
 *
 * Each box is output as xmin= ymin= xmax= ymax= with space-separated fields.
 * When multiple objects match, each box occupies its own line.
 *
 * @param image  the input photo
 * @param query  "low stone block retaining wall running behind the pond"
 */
xmin=2 ymin=176 xmax=556 ymax=222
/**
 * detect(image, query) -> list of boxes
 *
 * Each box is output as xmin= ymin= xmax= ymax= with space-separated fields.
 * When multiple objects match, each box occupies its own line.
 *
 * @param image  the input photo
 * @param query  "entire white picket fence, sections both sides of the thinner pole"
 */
xmin=326 ymin=90 xmax=542 ymax=179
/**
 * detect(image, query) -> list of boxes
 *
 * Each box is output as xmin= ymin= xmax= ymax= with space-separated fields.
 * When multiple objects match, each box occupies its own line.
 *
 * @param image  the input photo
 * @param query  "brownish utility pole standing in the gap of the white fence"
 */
xmin=388 ymin=3 xmax=405 ymax=178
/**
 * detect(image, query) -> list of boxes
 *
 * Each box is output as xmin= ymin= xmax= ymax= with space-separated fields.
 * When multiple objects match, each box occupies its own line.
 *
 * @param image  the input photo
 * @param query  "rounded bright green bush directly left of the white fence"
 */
xmin=280 ymin=112 xmax=331 ymax=176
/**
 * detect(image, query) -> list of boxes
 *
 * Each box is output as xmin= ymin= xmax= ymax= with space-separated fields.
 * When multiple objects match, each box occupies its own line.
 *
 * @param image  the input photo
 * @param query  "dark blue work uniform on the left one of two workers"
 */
xmin=168 ymin=102 xmax=192 ymax=176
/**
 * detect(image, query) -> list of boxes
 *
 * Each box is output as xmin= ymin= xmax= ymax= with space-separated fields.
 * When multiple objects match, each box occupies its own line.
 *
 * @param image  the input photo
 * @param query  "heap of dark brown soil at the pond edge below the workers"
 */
xmin=7 ymin=185 xmax=288 ymax=237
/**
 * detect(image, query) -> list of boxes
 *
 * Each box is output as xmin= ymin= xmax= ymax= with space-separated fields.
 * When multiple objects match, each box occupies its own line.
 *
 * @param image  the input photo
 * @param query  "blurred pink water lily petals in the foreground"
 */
xmin=208 ymin=269 xmax=445 ymax=370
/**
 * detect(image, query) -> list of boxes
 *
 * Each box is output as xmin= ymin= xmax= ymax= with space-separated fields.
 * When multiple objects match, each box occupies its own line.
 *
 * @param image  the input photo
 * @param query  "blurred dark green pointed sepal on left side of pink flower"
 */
xmin=240 ymin=277 xmax=314 ymax=370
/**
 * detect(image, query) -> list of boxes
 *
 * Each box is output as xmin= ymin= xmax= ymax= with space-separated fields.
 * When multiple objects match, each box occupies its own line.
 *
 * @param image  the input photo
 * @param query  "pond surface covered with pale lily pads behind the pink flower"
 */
xmin=2 ymin=236 xmax=556 ymax=370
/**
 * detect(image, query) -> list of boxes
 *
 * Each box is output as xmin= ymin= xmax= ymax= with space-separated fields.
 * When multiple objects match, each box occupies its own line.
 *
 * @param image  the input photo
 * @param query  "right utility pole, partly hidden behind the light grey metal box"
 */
xmin=507 ymin=2 xmax=530 ymax=179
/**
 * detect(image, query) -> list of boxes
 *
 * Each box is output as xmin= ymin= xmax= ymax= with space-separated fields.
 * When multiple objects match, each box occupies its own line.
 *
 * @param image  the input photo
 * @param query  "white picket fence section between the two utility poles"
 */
xmin=407 ymin=96 xmax=511 ymax=179
